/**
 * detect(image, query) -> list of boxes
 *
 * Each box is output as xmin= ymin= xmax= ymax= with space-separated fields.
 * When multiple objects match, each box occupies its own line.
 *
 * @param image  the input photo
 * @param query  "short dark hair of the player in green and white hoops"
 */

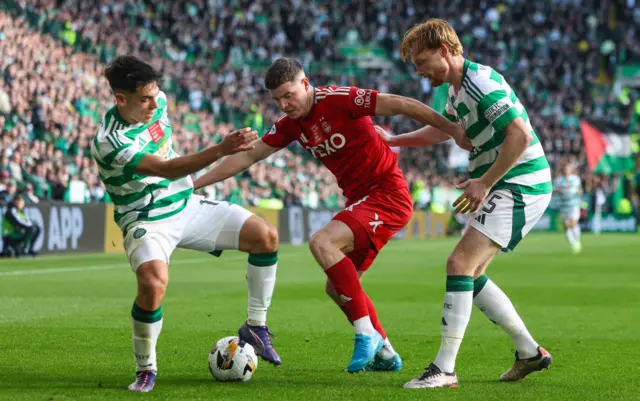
xmin=104 ymin=55 xmax=162 ymax=92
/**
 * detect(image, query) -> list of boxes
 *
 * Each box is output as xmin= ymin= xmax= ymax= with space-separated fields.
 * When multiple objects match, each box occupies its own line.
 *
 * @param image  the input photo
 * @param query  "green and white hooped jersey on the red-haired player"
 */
xmin=444 ymin=60 xmax=553 ymax=195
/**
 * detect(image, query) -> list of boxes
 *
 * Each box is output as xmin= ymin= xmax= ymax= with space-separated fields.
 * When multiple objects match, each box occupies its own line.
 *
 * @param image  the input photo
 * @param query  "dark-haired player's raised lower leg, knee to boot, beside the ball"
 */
xmin=232 ymin=215 xmax=282 ymax=366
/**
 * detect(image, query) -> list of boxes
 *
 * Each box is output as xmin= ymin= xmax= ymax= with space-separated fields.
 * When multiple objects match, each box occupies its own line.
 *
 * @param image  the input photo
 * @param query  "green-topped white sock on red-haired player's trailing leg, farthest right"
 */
xmin=473 ymin=275 xmax=538 ymax=359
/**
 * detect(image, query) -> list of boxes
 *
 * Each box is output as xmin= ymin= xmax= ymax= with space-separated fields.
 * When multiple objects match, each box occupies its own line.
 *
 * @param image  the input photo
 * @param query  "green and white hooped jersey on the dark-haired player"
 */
xmin=91 ymin=92 xmax=193 ymax=232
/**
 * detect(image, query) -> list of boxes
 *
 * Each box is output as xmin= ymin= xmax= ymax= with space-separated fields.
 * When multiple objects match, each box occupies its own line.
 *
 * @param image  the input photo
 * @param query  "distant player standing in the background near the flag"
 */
xmin=553 ymin=163 xmax=582 ymax=253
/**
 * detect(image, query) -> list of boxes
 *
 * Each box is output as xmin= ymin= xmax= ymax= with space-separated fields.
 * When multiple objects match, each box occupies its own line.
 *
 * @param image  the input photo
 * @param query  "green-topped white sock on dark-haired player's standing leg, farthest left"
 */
xmin=131 ymin=304 xmax=163 ymax=372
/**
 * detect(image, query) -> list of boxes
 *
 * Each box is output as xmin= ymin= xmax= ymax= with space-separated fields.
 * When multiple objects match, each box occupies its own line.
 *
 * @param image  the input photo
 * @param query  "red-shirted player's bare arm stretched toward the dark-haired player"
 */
xmin=193 ymin=139 xmax=280 ymax=190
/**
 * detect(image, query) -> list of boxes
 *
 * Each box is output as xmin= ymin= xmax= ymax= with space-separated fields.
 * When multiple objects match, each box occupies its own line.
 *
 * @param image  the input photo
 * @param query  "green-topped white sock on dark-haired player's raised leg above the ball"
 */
xmin=247 ymin=252 xmax=278 ymax=326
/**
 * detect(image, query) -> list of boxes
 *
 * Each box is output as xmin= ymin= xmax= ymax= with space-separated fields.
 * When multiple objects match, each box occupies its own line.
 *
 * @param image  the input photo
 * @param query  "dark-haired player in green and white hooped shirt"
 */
xmin=91 ymin=56 xmax=281 ymax=392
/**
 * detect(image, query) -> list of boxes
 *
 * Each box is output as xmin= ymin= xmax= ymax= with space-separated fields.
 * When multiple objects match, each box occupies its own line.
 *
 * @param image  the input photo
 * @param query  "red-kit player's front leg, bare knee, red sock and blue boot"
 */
xmin=309 ymin=220 xmax=384 ymax=373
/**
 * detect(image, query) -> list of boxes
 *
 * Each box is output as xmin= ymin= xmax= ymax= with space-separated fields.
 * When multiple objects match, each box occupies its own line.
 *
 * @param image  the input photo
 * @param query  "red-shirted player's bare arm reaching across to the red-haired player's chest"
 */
xmin=376 ymin=93 xmax=464 ymax=139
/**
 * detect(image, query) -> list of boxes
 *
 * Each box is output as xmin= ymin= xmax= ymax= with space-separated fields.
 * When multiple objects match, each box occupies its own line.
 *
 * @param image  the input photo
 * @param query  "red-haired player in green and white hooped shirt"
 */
xmin=380 ymin=19 xmax=552 ymax=388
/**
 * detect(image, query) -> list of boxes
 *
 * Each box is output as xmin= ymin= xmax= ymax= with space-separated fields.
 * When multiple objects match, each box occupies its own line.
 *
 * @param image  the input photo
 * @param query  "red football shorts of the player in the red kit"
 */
xmin=333 ymin=187 xmax=413 ymax=271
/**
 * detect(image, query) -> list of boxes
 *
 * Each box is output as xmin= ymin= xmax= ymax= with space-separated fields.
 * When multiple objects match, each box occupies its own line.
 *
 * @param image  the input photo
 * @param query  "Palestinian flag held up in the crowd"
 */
xmin=580 ymin=120 xmax=634 ymax=174
